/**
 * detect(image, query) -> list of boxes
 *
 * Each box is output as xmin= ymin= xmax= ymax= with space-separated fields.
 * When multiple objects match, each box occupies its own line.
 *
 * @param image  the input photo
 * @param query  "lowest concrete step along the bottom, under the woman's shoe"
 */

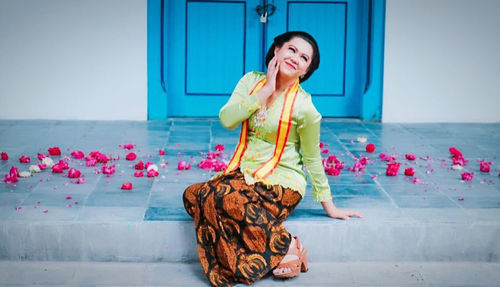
xmin=0 ymin=261 xmax=500 ymax=287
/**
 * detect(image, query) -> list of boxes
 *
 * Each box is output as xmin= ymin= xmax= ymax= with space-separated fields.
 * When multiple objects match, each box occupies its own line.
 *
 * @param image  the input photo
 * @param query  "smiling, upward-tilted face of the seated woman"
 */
xmin=274 ymin=37 xmax=313 ymax=78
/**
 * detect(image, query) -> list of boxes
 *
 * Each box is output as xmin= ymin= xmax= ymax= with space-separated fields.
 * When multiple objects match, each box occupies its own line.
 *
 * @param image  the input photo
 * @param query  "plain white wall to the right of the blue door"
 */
xmin=382 ymin=0 xmax=500 ymax=122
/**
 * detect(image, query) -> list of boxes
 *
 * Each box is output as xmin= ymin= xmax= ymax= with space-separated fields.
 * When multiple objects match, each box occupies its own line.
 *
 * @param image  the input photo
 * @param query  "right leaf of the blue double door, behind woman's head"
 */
xmin=266 ymin=0 xmax=368 ymax=117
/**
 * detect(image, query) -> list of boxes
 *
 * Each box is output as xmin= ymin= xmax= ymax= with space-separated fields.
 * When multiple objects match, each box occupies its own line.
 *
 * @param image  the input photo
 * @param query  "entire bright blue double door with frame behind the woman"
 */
xmin=148 ymin=0 xmax=385 ymax=120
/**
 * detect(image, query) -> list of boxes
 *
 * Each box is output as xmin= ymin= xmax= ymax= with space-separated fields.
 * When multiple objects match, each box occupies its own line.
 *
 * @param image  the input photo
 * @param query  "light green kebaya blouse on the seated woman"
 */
xmin=219 ymin=72 xmax=332 ymax=202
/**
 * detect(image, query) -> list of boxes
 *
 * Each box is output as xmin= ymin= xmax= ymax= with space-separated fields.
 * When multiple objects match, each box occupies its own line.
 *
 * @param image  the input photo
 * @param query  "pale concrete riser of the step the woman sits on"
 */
xmin=0 ymin=207 xmax=500 ymax=262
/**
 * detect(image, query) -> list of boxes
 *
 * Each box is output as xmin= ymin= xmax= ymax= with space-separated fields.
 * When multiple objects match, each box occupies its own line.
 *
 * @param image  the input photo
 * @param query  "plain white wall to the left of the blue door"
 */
xmin=0 ymin=0 xmax=147 ymax=120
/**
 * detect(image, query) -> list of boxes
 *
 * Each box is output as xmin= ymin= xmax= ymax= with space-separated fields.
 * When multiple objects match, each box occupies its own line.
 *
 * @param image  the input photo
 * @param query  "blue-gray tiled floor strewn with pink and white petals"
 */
xmin=0 ymin=119 xmax=500 ymax=221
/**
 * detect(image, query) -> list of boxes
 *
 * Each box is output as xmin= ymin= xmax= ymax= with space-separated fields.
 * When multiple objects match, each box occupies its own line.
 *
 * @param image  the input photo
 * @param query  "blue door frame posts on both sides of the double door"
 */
xmin=147 ymin=0 xmax=386 ymax=121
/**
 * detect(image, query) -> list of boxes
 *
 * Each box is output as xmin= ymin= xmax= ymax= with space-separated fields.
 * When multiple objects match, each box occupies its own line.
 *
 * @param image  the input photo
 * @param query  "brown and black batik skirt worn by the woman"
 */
xmin=183 ymin=170 xmax=302 ymax=286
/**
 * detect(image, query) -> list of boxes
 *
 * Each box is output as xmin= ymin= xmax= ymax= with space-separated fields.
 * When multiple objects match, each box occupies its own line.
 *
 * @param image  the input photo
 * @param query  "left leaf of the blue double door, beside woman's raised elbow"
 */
xmin=165 ymin=0 xmax=263 ymax=116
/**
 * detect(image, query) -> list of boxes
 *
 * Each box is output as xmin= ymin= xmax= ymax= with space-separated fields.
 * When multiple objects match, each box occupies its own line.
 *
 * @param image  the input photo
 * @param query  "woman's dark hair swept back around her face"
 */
xmin=266 ymin=31 xmax=319 ymax=83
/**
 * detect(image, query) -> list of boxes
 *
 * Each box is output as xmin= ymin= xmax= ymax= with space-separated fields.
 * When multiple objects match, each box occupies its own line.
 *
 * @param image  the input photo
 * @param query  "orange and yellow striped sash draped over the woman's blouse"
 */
xmin=224 ymin=78 xmax=299 ymax=180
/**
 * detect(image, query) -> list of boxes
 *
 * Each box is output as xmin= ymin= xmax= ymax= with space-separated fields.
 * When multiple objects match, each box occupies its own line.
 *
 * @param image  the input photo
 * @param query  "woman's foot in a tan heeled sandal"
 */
xmin=273 ymin=237 xmax=307 ymax=278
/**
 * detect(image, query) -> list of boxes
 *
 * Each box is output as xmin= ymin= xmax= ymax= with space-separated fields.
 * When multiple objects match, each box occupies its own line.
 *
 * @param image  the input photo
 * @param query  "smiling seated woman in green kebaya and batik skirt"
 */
xmin=183 ymin=31 xmax=362 ymax=286
